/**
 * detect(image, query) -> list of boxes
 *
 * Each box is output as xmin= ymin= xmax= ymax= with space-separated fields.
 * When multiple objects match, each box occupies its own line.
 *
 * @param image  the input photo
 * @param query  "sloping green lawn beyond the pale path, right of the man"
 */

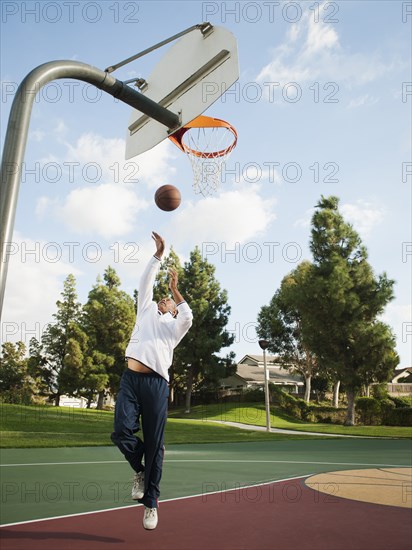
xmin=169 ymin=403 xmax=412 ymax=438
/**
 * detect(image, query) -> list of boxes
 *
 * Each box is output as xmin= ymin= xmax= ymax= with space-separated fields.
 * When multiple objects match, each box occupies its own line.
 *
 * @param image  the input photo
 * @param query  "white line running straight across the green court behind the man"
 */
xmin=0 ymin=458 xmax=411 ymax=468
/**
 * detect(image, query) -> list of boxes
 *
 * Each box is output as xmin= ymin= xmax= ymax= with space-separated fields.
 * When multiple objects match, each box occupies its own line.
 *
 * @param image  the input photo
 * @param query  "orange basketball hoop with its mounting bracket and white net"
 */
xmin=169 ymin=115 xmax=237 ymax=197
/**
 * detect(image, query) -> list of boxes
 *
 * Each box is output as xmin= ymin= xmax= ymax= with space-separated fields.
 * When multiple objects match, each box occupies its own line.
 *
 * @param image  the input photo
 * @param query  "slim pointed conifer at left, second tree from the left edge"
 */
xmin=29 ymin=274 xmax=87 ymax=406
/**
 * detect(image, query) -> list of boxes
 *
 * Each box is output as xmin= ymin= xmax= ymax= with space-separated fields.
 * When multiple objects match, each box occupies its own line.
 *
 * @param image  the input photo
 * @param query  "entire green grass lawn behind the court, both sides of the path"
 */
xmin=0 ymin=403 xmax=412 ymax=448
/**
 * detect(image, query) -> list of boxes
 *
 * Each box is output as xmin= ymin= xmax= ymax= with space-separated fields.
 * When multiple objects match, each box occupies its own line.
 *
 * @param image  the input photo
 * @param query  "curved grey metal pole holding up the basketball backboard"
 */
xmin=0 ymin=61 xmax=180 ymax=324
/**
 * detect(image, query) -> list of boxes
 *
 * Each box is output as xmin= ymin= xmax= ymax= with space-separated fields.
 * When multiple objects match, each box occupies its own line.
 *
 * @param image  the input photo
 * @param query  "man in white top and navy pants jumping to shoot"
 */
xmin=111 ymin=231 xmax=193 ymax=529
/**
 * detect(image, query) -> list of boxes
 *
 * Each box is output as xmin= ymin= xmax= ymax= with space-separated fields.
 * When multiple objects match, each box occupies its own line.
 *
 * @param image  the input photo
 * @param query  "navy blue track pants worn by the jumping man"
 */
xmin=111 ymin=369 xmax=169 ymax=508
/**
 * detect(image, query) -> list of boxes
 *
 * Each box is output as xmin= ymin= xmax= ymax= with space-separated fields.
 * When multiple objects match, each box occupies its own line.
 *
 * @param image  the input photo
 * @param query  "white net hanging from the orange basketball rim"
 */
xmin=182 ymin=127 xmax=236 ymax=197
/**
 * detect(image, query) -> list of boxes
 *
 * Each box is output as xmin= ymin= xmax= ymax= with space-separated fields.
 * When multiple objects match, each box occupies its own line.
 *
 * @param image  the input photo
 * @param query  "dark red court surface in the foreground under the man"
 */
xmin=0 ymin=478 xmax=412 ymax=550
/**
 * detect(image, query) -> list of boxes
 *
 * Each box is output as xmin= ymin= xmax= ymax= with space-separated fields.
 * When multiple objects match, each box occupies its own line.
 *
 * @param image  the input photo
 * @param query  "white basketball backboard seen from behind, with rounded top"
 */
xmin=126 ymin=27 xmax=239 ymax=159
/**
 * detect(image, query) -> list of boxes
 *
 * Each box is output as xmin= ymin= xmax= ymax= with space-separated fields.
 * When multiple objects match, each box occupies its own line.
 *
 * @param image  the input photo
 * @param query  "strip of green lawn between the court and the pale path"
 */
xmin=0 ymin=404 xmax=328 ymax=448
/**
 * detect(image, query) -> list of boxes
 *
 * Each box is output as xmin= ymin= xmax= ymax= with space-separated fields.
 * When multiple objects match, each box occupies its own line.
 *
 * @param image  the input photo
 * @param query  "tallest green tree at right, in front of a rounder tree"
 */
xmin=300 ymin=197 xmax=399 ymax=425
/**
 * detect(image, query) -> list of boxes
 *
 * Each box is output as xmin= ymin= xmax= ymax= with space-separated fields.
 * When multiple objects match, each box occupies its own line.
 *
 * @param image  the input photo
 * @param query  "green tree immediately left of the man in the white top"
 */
xmin=82 ymin=266 xmax=135 ymax=409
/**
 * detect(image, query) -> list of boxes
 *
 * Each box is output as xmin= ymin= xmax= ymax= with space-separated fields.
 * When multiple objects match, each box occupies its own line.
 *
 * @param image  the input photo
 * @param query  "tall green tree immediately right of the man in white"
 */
xmin=174 ymin=247 xmax=234 ymax=412
